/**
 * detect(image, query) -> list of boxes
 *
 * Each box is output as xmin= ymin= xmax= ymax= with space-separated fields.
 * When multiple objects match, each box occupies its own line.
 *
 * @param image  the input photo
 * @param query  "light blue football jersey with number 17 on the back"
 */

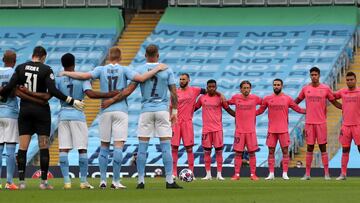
xmin=90 ymin=64 xmax=137 ymax=113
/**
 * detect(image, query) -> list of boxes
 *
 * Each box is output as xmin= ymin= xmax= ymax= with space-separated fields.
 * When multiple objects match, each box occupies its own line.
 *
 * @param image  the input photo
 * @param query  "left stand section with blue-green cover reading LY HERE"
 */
xmin=0 ymin=8 xmax=123 ymax=166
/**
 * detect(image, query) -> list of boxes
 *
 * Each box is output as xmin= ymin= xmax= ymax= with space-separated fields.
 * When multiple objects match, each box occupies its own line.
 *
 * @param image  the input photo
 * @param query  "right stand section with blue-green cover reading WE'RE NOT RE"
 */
xmin=82 ymin=6 xmax=357 ymax=166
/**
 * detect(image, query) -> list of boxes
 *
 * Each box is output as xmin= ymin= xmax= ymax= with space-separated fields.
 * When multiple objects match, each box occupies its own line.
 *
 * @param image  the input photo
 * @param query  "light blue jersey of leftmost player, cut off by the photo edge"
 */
xmin=0 ymin=67 xmax=19 ymax=119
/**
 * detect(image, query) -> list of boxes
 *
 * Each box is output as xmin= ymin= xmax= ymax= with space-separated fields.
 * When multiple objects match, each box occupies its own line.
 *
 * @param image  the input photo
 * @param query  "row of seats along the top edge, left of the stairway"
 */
xmin=0 ymin=0 xmax=124 ymax=8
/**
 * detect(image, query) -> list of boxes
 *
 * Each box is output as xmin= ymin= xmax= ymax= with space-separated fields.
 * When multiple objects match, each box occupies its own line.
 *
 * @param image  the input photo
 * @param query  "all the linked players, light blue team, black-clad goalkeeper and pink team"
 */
xmin=0 ymin=45 xmax=360 ymax=190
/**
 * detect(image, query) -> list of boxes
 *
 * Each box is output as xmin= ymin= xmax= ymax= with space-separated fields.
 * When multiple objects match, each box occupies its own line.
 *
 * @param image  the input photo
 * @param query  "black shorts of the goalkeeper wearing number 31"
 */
xmin=18 ymin=105 xmax=51 ymax=136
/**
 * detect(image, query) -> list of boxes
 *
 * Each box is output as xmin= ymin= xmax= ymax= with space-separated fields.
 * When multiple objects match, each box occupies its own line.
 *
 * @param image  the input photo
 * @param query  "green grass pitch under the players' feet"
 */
xmin=0 ymin=177 xmax=360 ymax=203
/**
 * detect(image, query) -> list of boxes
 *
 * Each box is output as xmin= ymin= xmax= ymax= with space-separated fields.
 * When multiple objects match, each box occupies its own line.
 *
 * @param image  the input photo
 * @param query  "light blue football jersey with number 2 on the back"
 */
xmin=136 ymin=63 xmax=175 ymax=112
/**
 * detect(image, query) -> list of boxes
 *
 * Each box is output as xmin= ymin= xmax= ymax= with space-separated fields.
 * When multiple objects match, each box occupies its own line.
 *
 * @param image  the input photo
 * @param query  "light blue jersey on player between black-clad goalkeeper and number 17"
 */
xmin=56 ymin=76 xmax=92 ymax=122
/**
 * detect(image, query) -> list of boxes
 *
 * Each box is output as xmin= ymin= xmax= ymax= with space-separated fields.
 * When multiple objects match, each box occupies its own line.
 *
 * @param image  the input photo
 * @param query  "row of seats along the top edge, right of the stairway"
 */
xmin=169 ymin=0 xmax=360 ymax=6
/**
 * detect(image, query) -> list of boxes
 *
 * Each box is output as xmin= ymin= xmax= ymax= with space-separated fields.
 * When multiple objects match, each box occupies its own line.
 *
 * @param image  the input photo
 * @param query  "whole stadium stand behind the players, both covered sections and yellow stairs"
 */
xmin=0 ymin=4 xmax=358 ymax=171
